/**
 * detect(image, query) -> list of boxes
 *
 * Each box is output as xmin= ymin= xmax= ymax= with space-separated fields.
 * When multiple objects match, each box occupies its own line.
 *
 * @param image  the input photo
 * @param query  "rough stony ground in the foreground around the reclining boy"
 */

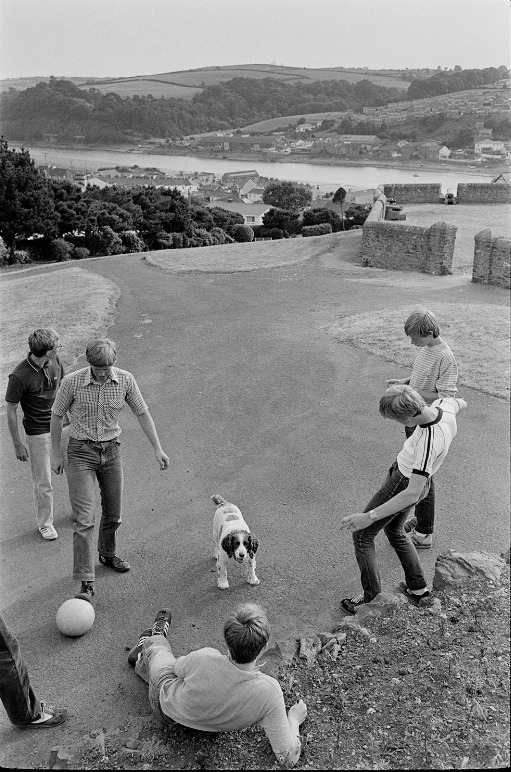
xmin=46 ymin=553 xmax=509 ymax=770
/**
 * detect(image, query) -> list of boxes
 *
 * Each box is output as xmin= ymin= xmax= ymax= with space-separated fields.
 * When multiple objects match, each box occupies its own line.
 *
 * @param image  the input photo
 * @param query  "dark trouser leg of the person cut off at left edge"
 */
xmin=0 ymin=616 xmax=42 ymax=726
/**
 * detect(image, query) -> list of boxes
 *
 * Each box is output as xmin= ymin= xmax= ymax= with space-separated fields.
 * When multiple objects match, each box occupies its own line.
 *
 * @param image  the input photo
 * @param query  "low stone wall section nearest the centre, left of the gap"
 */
xmin=362 ymin=220 xmax=457 ymax=276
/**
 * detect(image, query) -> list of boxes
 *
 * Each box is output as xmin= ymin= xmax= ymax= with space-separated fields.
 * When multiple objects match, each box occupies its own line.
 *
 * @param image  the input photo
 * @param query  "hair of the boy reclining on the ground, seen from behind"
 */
xmin=224 ymin=603 xmax=270 ymax=665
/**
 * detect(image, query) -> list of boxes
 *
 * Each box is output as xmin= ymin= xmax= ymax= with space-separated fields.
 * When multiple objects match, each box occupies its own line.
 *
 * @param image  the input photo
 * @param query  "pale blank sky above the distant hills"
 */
xmin=0 ymin=0 xmax=510 ymax=78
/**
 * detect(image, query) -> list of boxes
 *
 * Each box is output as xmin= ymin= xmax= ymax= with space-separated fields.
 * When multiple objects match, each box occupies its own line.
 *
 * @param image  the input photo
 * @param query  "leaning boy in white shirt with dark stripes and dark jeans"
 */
xmin=341 ymin=384 xmax=467 ymax=614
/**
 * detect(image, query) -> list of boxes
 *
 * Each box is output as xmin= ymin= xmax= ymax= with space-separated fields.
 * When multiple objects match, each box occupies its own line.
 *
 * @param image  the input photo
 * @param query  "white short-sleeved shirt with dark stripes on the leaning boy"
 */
xmin=397 ymin=397 xmax=460 ymax=477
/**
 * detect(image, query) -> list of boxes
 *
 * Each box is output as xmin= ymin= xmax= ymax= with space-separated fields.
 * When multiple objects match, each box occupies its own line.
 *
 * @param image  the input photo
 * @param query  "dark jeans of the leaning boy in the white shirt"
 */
xmin=353 ymin=462 xmax=427 ymax=603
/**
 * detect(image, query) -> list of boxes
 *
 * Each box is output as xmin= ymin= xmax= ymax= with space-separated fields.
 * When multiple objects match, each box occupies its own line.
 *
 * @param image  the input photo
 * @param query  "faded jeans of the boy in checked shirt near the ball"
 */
xmin=67 ymin=437 xmax=123 ymax=582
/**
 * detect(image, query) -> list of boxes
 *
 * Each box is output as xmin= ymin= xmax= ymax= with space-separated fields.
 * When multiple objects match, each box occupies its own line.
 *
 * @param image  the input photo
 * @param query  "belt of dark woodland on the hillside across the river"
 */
xmin=0 ymin=77 xmax=408 ymax=142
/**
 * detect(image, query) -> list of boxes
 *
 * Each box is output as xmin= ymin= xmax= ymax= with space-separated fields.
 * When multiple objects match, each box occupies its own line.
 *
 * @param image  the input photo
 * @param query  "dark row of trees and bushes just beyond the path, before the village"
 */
xmin=0 ymin=139 xmax=360 ymax=262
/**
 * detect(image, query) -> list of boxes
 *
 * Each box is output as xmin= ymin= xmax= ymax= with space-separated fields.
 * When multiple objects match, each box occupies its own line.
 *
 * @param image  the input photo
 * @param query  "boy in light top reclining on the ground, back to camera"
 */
xmin=128 ymin=603 xmax=307 ymax=766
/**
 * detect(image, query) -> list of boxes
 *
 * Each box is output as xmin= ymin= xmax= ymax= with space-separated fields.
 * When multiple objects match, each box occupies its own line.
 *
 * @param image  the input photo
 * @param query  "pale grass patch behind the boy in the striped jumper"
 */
xmin=326 ymin=303 xmax=510 ymax=400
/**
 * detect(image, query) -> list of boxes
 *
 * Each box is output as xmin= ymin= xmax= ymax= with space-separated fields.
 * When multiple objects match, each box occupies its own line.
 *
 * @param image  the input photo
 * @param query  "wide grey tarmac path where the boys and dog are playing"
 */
xmin=0 ymin=253 xmax=509 ymax=766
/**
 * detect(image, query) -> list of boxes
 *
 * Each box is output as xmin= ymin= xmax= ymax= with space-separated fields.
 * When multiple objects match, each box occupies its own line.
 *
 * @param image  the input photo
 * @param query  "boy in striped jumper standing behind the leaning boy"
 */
xmin=387 ymin=310 xmax=458 ymax=549
